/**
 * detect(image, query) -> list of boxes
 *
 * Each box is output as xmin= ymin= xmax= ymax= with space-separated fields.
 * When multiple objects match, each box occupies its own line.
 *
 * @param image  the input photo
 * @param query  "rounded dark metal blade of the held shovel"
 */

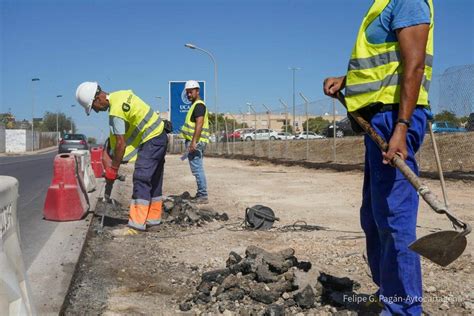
xmin=408 ymin=231 xmax=467 ymax=267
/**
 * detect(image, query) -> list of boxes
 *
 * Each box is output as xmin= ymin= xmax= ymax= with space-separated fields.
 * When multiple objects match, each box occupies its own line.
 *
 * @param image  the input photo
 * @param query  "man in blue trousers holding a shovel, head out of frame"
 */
xmin=323 ymin=0 xmax=433 ymax=315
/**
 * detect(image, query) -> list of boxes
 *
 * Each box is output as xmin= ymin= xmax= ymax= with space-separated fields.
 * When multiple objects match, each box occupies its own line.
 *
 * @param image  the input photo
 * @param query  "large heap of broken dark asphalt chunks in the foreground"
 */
xmin=179 ymin=246 xmax=368 ymax=315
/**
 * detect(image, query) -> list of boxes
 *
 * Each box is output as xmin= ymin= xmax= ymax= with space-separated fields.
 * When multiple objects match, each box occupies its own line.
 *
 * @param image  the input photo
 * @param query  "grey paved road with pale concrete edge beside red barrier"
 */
xmin=0 ymin=151 xmax=98 ymax=315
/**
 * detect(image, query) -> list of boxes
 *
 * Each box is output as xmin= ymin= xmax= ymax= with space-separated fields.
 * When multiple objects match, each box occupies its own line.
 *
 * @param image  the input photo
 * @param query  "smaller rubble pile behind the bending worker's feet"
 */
xmin=163 ymin=192 xmax=229 ymax=226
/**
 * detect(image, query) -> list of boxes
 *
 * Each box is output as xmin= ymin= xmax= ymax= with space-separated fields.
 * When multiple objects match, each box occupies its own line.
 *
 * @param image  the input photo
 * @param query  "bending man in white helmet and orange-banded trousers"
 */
xmin=76 ymin=82 xmax=168 ymax=235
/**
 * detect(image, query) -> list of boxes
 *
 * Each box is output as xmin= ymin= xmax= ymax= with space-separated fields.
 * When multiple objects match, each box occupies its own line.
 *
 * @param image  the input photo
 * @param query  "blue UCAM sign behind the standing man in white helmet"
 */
xmin=169 ymin=81 xmax=206 ymax=134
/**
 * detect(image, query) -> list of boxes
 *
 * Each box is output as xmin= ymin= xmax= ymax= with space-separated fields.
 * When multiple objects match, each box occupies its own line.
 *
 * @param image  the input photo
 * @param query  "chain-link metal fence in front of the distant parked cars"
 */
xmin=170 ymin=65 xmax=474 ymax=173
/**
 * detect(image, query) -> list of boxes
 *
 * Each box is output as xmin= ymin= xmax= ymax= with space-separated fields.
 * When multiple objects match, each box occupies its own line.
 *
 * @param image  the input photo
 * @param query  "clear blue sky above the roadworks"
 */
xmin=0 ymin=0 xmax=474 ymax=136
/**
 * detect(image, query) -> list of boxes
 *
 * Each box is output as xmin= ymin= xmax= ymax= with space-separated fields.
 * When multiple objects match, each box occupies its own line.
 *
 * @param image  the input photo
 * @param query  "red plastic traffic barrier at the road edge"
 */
xmin=43 ymin=154 xmax=88 ymax=221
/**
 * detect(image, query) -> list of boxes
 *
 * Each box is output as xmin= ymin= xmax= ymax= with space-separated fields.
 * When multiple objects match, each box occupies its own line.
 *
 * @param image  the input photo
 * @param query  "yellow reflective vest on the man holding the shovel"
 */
xmin=345 ymin=0 xmax=434 ymax=112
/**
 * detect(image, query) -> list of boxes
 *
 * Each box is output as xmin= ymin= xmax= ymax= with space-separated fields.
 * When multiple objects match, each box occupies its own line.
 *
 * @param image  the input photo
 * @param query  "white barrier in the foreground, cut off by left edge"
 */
xmin=0 ymin=176 xmax=35 ymax=316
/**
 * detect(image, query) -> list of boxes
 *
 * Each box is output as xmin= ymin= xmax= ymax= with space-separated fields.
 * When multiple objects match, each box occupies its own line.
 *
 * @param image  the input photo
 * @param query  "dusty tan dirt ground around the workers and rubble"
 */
xmin=64 ymin=155 xmax=474 ymax=315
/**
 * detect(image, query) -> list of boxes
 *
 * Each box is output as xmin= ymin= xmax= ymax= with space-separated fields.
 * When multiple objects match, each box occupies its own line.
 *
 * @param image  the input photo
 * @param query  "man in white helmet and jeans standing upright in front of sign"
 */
xmin=181 ymin=80 xmax=210 ymax=204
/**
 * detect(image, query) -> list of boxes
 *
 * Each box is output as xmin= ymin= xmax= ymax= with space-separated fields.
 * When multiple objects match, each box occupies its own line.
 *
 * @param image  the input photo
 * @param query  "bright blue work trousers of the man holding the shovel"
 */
xmin=360 ymin=107 xmax=426 ymax=315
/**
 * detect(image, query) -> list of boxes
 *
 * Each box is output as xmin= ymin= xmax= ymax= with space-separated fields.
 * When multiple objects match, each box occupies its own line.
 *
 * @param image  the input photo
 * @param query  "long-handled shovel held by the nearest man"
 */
xmin=337 ymin=92 xmax=471 ymax=267
